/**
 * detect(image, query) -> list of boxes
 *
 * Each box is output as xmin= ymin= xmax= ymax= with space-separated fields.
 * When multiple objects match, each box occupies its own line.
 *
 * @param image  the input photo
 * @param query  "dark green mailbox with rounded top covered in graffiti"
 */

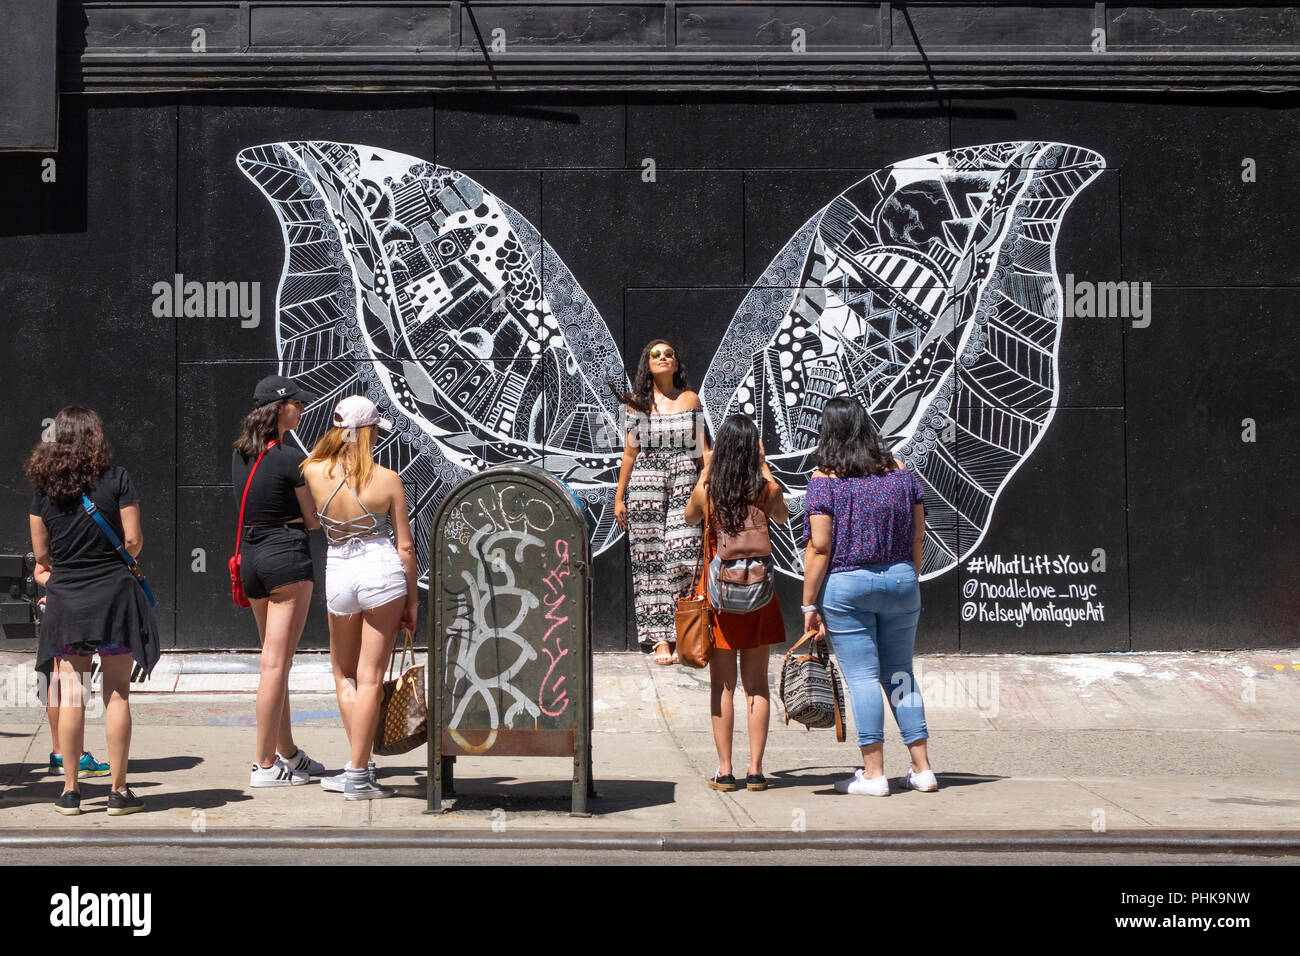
xmin=429 ymin=464 xmax=592 ymax=813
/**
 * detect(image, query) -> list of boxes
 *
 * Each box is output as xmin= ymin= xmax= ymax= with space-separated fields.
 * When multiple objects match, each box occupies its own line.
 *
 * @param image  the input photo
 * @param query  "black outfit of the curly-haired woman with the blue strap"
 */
xmin=30 ymin=466 xmax=160 ymax=675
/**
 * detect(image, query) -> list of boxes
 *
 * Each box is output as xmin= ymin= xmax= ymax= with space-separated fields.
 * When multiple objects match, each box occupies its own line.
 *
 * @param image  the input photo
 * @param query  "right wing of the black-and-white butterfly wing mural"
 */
xmin=701 ymin=142 xmax=1105 ymax=579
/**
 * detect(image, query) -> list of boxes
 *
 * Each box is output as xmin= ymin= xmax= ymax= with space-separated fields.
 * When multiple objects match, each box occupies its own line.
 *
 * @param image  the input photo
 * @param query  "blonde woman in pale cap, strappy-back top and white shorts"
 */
xmin=303 ymin=395 xmax=420 ymax=800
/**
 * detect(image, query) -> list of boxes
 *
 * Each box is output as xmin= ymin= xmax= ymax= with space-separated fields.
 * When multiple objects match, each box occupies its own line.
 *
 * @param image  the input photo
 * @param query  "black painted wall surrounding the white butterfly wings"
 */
xmin=0 ymin=94 xmax=1300 ymax=652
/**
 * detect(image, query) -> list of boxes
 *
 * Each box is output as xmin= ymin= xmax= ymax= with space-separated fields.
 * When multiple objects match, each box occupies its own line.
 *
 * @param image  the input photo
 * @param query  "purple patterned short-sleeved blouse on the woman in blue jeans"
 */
xmin=803 ymin=468 xmax=924 ymax=574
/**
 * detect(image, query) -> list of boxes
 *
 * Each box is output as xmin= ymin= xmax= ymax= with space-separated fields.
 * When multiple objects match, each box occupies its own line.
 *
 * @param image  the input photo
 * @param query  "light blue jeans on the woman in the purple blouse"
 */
xmin=822 ymin=561 xmax=930 ymax=747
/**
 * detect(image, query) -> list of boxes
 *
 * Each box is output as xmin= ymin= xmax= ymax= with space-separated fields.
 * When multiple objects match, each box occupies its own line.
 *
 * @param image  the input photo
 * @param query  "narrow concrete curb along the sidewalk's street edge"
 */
xmin=0 ymin=829 xmax=1300 ymax=856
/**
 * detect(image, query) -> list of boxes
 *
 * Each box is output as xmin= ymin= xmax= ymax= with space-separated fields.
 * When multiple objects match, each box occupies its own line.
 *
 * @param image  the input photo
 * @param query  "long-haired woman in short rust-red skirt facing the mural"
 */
xmin=686 ymin=415 xmax=790 ymax=791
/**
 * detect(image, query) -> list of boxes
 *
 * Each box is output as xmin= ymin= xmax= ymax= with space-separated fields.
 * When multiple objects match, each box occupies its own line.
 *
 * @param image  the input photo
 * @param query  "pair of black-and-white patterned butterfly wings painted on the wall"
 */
xmin=238 ymin=142 xmax=1105 ymax=584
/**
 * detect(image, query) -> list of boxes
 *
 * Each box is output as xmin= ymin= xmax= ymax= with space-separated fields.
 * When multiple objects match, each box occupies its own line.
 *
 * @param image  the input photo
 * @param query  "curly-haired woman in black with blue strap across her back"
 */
xmin=26 ymin=405 xmax=160 ymax=817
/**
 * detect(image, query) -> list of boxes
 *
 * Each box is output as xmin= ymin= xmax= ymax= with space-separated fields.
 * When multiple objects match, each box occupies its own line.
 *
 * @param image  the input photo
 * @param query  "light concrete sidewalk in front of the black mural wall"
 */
xmin=0 ymin=652 xmax=1300 ymax=851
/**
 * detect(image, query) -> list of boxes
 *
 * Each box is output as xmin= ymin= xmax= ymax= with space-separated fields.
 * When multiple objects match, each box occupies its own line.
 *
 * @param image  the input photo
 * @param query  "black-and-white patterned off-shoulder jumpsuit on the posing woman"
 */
xmin=627 ymin=408 xmax=703 ymax=648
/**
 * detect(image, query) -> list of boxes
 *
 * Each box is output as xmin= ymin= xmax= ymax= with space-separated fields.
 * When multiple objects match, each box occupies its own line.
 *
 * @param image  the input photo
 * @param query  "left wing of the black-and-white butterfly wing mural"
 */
xmin=237 ymin=142 xmax=627 ymax=585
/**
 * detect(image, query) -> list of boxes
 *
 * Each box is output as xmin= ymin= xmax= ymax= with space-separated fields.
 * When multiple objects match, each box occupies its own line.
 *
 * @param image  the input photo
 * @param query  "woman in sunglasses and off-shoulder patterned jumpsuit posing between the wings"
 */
xmin=610 ymin=338 xmax=709 ymax=663
